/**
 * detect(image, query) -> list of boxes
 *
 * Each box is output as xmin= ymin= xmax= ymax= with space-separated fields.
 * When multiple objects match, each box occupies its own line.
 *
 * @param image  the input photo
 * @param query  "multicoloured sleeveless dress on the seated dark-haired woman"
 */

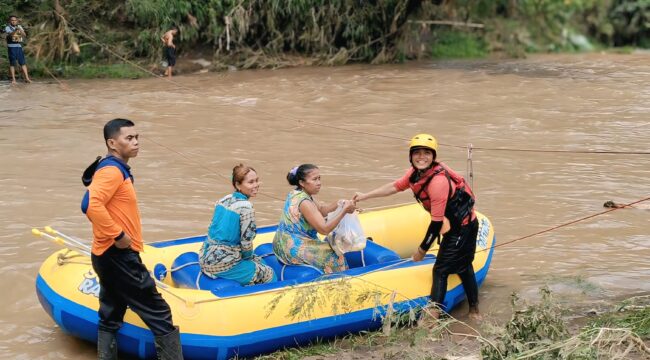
xmin=273 ymin=190 xmax=348 ymax=274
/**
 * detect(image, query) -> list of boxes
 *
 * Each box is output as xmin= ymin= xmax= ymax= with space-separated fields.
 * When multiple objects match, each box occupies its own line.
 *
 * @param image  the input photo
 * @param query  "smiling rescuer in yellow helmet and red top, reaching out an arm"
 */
xmin=353 ymin=134 xmax=480 ymax=319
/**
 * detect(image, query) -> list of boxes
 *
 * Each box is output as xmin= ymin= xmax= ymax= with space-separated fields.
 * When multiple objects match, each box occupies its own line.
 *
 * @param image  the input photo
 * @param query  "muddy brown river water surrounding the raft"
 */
xmin=0 ymin=53 xmax=650 ymax=359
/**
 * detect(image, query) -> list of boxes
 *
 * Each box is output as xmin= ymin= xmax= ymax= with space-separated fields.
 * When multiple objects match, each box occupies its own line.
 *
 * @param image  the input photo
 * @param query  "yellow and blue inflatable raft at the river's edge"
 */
xmin=36 ymin=204 xmax=496 ymax=359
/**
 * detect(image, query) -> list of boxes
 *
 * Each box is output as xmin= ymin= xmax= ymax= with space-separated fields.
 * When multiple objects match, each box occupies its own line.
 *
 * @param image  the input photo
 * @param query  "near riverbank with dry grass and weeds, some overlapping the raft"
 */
xmin=260 ymin=279 xmax=650 ymax=360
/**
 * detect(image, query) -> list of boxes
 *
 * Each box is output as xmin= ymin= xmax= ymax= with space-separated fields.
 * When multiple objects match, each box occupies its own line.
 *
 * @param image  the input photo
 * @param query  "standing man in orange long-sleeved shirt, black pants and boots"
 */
xmin=81 ymin=119 xmax=183 ymax=360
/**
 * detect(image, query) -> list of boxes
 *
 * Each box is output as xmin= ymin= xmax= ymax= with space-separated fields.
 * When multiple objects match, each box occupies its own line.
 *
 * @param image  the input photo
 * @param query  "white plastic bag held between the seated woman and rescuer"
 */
xmin=327 ymin=206 xmax=366 ymax=255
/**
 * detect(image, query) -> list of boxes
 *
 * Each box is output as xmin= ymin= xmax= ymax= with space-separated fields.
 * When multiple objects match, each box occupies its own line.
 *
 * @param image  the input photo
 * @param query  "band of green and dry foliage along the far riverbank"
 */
xmin=0 ymin=0 xmax=650 ymax=76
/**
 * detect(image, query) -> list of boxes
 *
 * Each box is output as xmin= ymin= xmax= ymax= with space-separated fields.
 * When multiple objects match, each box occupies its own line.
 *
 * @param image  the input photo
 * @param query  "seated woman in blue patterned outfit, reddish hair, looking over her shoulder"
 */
xmin=199 ymin=164 xmax=276 ymax=285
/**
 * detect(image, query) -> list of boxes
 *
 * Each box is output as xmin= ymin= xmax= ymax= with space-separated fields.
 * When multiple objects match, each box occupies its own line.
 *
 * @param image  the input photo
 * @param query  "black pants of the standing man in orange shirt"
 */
xmin=91 ymin=246 xmax=175 ymax=336
